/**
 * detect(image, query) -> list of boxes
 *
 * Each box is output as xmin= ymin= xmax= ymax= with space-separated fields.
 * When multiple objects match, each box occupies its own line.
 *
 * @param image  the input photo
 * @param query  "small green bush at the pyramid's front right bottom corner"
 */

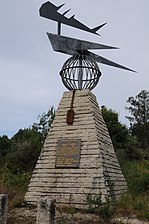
xmin=87 ymin=193 xmax=113 ymax=219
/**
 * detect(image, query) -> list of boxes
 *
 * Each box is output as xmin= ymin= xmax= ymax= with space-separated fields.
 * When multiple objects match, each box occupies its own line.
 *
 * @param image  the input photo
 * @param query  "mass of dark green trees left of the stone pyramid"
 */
xmin=0 ymin=107 xmax=55 ymax=173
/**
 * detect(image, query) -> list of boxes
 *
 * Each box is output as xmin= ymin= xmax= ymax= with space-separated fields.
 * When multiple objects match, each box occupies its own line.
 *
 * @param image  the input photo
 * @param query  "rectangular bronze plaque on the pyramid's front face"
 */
xmin=55 ymin=139 xmax=81 ymax=168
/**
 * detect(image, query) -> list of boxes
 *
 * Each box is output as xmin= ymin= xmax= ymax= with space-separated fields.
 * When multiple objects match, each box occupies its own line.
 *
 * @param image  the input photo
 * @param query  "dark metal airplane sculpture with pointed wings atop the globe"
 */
xmin=39 ymin=2 xmax=136 ymax=72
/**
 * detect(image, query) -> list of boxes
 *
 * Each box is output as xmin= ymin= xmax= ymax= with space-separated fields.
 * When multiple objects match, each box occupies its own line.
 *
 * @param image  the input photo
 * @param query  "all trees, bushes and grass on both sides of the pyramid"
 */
xmin=0 ymin=90 xmax=149 ymax=220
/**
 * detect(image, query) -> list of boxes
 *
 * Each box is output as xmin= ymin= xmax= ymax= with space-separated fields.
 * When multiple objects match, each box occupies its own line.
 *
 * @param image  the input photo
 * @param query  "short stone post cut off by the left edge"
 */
xmin=0 ymin=194 xmax=8 ymax=224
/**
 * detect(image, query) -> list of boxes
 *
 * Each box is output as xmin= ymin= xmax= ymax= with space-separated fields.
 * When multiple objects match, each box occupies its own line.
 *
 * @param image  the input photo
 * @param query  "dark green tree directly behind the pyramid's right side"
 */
xmin=101 ymin=106 xmax=142 ymax=160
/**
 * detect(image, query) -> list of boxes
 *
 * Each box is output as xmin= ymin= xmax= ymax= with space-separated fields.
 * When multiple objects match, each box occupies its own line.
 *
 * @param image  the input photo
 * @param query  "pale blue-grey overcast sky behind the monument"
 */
xmin=0 ymin=0 xmax=149 ymax=137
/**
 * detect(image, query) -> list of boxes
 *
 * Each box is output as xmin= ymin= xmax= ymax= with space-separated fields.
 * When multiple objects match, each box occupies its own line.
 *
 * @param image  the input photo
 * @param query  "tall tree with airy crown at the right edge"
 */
xmin=126 ymin=90 xmax=149 ymax=149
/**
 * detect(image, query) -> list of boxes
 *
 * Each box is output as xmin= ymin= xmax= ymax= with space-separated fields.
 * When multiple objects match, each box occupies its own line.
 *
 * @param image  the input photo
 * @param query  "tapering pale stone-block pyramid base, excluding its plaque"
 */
xmin=25 ymin=90 xmax=127 ymax=208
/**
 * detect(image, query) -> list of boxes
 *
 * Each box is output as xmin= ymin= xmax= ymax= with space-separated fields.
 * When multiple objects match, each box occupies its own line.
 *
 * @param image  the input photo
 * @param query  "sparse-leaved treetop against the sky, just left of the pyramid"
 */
xmin=32 ymin=106 xmax=55 ymax=141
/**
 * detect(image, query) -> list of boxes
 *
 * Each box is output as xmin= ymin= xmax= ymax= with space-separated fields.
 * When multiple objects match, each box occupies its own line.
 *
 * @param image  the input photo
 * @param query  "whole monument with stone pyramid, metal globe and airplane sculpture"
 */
xmin=25 ymin=2 xmax=134 ymax=209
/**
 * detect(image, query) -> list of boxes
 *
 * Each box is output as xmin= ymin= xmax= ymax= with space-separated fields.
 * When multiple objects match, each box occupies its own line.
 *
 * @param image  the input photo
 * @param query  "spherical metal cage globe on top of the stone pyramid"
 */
xmin=60 ymin=53 xmax=101 ymax=90
